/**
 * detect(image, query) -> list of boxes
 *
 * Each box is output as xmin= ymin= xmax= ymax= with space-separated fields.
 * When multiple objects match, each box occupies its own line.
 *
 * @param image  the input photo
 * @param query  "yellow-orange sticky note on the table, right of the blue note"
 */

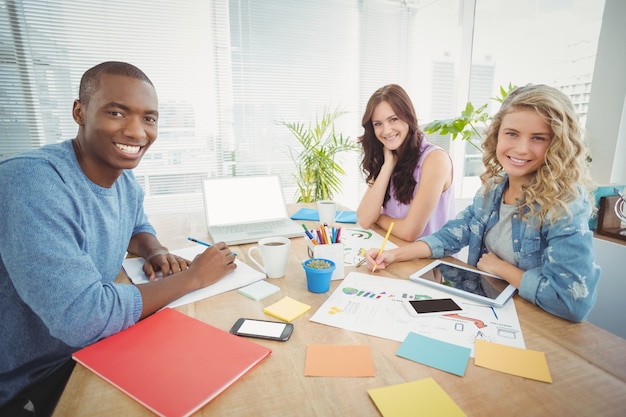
xmin=474 ymin=339 xmax=552 ymax=383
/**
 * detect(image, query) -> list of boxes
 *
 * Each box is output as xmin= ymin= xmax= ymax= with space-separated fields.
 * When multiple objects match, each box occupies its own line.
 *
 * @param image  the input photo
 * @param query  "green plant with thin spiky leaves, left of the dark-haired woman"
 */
xmin=279 ymin=108 xmax=360 ymax=203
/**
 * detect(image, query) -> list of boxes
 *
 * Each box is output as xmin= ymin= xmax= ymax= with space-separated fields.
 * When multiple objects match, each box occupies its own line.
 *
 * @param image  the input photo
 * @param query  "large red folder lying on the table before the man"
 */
xmin=73 ymin=308 xmax=272 ymax=417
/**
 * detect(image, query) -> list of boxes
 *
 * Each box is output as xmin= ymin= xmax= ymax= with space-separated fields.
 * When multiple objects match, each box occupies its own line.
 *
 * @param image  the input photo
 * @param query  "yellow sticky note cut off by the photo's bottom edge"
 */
xmin=367 ymin=378 xmax=466 ymax=417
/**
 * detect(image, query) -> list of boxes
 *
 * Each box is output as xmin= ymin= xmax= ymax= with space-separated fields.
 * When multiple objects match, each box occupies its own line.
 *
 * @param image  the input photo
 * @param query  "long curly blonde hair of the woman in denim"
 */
xmin=480 ymin=84 xmax=594 ymax=226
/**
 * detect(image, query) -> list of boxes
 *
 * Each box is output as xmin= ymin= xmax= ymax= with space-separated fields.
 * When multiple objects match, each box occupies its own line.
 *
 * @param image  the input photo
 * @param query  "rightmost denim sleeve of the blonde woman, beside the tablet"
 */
xmin=519 ymin=198 xmax=600 ymax=322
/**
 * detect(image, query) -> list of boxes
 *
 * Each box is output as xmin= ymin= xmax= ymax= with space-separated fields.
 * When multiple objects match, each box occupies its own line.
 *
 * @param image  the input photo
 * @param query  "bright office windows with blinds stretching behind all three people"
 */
xmin=0 ymin=0 xmax=604 ymax=214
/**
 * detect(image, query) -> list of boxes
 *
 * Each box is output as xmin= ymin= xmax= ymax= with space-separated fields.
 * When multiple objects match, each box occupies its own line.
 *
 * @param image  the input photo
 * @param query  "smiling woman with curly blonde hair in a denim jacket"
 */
xmin=366 ymin=85 xmax=600 ymax=321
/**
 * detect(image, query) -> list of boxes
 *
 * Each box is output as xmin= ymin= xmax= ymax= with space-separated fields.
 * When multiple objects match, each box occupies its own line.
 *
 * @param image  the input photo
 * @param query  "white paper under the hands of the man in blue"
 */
xmin=122 ymin=245 xmax=265 ymax=307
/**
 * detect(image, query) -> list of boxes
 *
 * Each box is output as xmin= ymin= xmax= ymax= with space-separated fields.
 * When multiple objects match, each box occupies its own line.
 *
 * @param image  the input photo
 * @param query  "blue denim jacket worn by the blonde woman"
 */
xmin=418 ymin=178 xmax=600 ymax=321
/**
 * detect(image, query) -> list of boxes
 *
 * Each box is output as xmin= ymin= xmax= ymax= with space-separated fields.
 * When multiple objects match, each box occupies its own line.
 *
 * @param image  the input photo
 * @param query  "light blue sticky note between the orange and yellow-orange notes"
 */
xmin=396 ymin=332 xmax=471 ymax=376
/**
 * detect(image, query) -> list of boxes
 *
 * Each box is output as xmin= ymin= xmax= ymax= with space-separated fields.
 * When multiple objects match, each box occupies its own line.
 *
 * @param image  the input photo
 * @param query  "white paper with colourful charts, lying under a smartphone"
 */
xmin=311 ymin=272 xmax=525 ymax=357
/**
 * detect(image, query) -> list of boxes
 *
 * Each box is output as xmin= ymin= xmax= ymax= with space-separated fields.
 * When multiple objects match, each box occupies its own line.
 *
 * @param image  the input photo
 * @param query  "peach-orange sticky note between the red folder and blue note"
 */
xmin=304 ymin=345 xmax=375 ymax=377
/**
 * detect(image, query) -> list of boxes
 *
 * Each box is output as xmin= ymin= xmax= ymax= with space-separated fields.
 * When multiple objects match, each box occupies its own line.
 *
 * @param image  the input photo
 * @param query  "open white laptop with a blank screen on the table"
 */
xmin=202 ymin=175 xmax=304 ymax=245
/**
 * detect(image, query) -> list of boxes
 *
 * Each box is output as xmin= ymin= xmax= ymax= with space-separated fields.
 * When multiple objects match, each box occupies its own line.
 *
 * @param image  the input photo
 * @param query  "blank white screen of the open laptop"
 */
xmin=202 ymin=175 xmax=287 ymax=226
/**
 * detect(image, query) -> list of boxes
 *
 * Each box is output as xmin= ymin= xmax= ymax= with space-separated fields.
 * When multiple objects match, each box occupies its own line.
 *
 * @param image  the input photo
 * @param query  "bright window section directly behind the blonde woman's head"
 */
xmin=456 ymin=0 xmax=604 ymax=197
